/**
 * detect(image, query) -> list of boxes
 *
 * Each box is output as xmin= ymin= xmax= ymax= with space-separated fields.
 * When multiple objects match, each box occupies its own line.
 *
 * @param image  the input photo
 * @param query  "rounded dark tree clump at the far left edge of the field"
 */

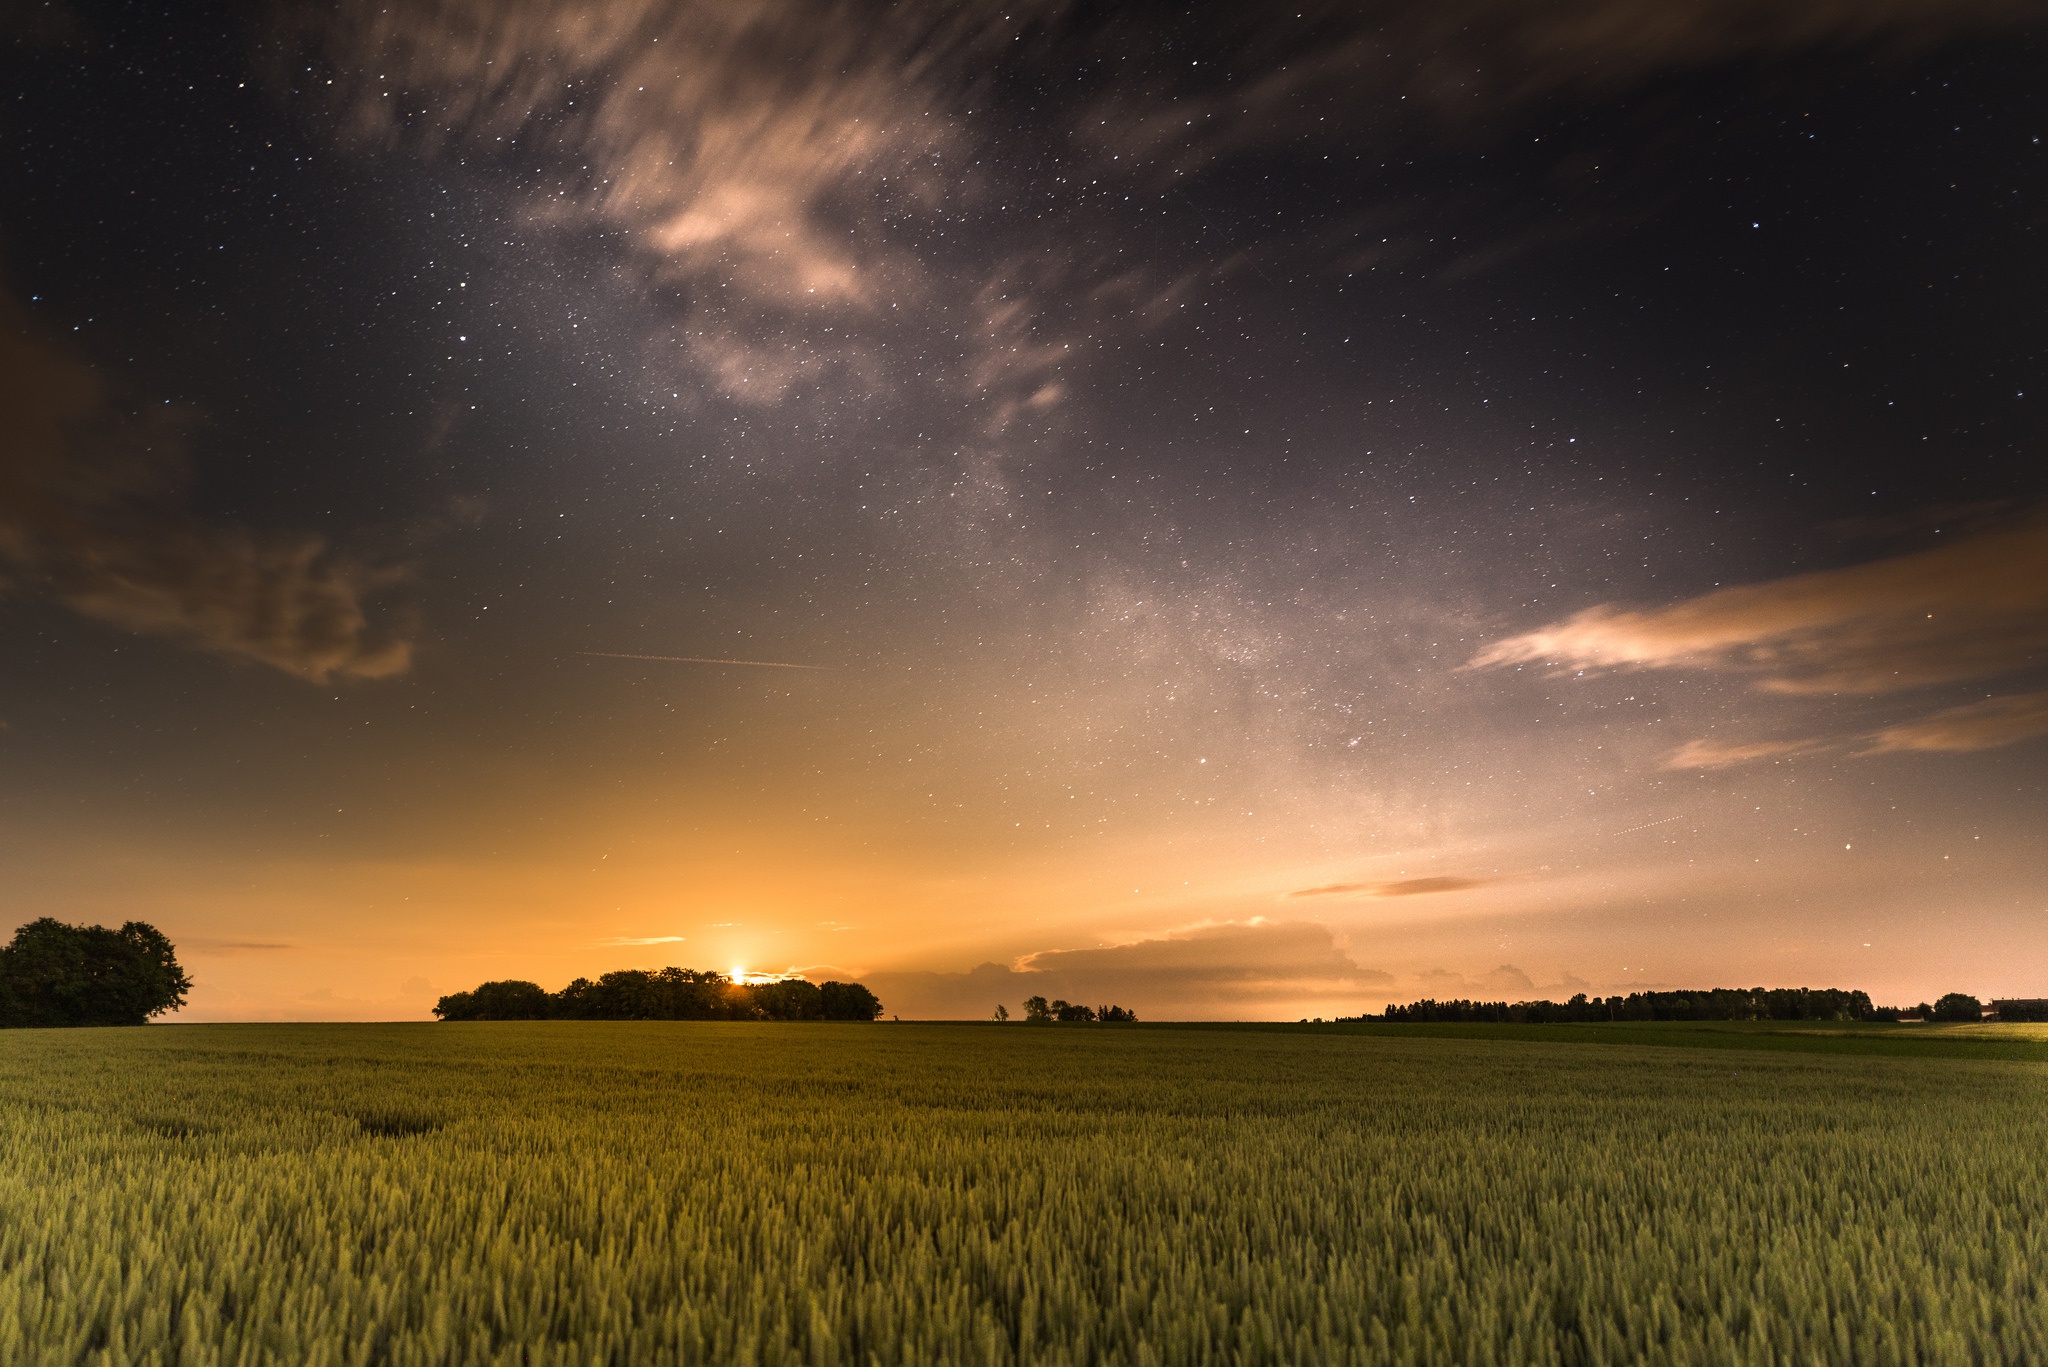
xmin=0 ymin=916 xmax=193 ymax=1027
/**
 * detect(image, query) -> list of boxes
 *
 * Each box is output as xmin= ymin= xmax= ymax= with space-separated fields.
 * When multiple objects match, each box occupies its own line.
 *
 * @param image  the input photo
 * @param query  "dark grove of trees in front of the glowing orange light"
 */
xmin=434 ymin=967 xmax=883 ymax=1021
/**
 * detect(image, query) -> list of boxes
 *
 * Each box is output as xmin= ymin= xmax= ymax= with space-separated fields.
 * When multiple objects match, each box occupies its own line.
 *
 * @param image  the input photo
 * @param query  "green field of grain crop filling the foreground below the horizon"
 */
xmin=0 ymin=1023 xmax=2048 ymax=1367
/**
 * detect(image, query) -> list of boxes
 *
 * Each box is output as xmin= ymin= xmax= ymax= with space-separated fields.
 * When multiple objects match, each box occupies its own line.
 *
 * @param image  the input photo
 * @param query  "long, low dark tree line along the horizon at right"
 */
xmin=1354 ymin=988 xmax=1985 ymax=1025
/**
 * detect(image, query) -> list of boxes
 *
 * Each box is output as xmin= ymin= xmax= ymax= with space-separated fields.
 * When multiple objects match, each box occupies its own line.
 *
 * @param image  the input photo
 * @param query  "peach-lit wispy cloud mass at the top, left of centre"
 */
xmin=279 ymin=0 xmax=1063 ymax=412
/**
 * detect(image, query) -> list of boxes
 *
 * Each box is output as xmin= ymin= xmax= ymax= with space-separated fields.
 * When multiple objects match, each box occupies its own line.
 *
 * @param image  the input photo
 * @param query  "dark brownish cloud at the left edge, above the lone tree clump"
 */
xmin=0 ymin=284 xmax=412 ymax=682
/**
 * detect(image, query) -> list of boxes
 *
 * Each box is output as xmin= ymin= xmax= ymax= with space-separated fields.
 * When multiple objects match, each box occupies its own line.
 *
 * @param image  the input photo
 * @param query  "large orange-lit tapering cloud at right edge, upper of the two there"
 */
xmin=1466 ymin=514 xmax=2048 ymax=693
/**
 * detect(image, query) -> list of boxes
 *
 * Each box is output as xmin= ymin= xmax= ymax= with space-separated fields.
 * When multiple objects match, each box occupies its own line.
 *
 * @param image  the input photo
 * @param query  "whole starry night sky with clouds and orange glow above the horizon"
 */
xmin=0 ymin=0 xmax=2048 ymax=1019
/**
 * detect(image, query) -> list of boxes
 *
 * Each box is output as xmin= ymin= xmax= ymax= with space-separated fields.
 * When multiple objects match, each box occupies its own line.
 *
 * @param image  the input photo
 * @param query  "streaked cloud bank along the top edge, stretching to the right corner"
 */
xmin=266 ymin=0 xmax=2040 ymax=441
